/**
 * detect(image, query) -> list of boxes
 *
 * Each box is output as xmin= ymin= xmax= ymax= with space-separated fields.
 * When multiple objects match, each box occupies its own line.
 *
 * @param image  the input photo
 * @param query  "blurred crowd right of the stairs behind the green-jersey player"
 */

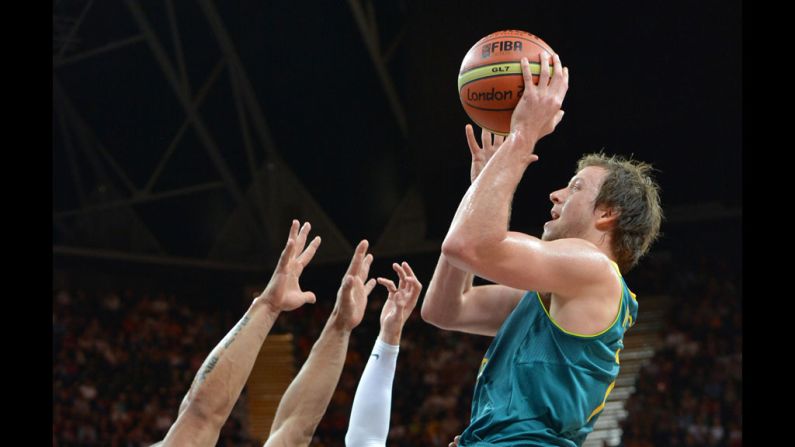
xmin=623 ymin=256 xmax=743 ymax=447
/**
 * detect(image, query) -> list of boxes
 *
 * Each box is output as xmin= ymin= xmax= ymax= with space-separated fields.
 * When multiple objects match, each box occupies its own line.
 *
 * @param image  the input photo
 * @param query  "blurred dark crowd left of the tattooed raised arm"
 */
xmin=52 ymin=290 xmax=253 ymax=447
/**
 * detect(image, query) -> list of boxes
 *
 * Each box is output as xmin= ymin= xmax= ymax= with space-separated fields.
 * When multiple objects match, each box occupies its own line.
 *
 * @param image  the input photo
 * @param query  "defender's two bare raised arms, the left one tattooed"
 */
xmin=155 ymin=220 xmax=376 ymax=447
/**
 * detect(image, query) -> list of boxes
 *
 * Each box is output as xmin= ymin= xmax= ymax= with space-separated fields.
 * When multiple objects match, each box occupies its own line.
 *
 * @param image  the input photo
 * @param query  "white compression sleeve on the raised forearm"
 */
xmin=345 ymin=338 xmax=400 ymax=447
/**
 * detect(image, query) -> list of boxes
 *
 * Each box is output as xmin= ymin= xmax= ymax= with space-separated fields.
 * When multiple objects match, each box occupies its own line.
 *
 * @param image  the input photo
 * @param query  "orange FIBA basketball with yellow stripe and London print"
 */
xmin=458 ymin=30 xmax=555 ymax=136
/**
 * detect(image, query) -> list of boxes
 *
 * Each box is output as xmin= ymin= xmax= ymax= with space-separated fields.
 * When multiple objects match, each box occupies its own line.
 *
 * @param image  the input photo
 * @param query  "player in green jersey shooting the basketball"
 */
xmin=422 ymin=54 xmax=662 ymax=447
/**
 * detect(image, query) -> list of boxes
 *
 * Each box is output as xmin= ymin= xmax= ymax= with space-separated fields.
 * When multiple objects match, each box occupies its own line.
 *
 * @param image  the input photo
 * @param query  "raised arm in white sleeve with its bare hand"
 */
xmin=345 ymin=262 xmax=422 ymax=447
